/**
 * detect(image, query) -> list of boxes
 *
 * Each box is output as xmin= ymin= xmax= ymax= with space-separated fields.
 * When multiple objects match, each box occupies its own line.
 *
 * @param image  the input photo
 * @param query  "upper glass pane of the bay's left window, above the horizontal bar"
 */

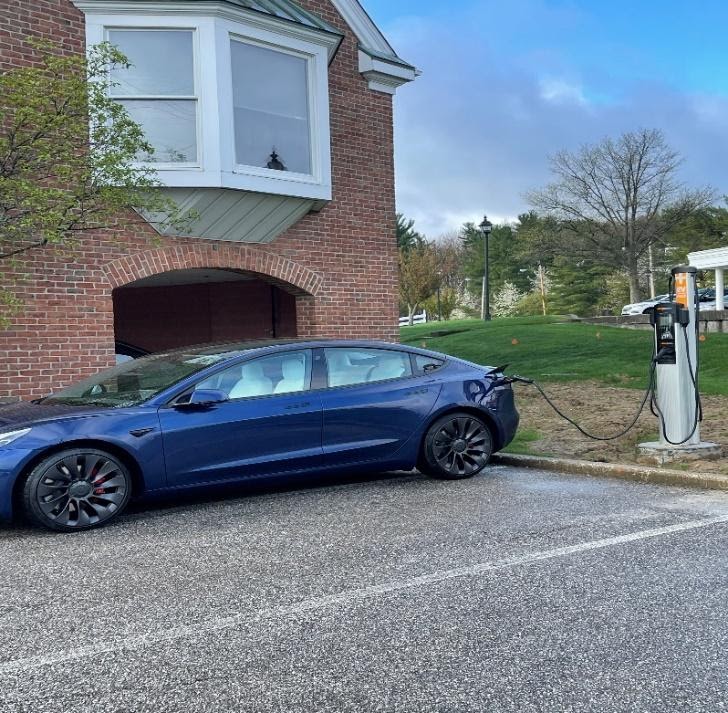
xmin=109 ymin=30 xmax=195 ymax=96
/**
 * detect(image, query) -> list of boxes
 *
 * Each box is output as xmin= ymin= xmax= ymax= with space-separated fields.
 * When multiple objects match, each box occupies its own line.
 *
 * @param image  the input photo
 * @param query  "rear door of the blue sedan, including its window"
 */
xmin=321 ymin=347 xmax=441 ymax=465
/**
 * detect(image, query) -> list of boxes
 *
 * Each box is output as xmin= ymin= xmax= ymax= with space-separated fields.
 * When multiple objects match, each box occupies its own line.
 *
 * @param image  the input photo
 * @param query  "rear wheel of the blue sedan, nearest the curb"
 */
xmin=418 ymin=412 xmax=493 ymax=480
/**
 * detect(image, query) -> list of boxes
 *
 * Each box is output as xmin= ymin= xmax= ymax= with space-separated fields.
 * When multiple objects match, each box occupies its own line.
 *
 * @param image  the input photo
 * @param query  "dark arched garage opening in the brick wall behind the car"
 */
xmin=113 ymin=268 xmax=296 ymax=353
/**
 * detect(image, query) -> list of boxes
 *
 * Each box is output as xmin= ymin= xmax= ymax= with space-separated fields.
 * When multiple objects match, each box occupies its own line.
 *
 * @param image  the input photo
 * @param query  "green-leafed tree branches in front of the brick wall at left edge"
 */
xmin=0 ymin=43 xmax=185 ymax=322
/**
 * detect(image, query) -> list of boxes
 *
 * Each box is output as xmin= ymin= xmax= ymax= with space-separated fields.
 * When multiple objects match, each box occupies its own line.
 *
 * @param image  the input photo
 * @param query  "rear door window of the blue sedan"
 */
xmin=324 ymin=347 xmax=412 ymax=387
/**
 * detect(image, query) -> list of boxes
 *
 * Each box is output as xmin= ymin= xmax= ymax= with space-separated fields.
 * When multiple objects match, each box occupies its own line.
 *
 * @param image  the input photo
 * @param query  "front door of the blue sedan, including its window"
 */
xmin=159 ymin=349 xmax=322 ymax=486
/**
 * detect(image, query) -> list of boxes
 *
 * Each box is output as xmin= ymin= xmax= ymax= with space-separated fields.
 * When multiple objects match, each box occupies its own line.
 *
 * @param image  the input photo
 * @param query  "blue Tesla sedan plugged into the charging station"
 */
xmin=0 ymin=341 xmax=518 ymax=532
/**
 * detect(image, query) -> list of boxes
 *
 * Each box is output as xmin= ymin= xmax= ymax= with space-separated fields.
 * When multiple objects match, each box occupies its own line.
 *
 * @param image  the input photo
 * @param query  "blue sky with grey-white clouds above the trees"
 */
xmin=362 ymin=0 xmax=728 ymax=238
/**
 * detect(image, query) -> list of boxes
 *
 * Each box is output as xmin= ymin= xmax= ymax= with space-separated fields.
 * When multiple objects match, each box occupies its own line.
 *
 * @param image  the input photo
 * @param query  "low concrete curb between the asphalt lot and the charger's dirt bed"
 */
xmin=491 ymin=453 xmax=728 ymax=490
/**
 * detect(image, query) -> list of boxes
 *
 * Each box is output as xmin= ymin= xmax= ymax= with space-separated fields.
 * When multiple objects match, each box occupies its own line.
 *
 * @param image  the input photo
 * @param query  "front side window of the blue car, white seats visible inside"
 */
xmin=195 ymin=349 xmax=312 ymax=400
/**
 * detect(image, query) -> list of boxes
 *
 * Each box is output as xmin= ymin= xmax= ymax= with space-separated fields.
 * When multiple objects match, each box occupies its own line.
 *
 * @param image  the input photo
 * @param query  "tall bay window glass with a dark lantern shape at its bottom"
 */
xmin=232 ymin=41 xmax=312 ymax=174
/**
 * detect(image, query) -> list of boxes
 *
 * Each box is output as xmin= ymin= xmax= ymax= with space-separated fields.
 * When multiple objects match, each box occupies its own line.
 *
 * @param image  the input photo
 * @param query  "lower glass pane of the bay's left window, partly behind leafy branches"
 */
xmin=121 ymin=99 xmax=197 ymax=163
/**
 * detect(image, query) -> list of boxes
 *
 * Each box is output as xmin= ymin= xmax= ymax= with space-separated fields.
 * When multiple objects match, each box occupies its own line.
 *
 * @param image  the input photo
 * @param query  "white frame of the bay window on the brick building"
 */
xmin=84 ymin=9 xmax=332 ymax=201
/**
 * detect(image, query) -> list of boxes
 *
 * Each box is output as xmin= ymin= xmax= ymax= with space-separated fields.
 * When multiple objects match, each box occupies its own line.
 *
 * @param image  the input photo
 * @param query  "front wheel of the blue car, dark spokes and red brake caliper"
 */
xmin=23 ymin=448 xmax=132 ymax=532
